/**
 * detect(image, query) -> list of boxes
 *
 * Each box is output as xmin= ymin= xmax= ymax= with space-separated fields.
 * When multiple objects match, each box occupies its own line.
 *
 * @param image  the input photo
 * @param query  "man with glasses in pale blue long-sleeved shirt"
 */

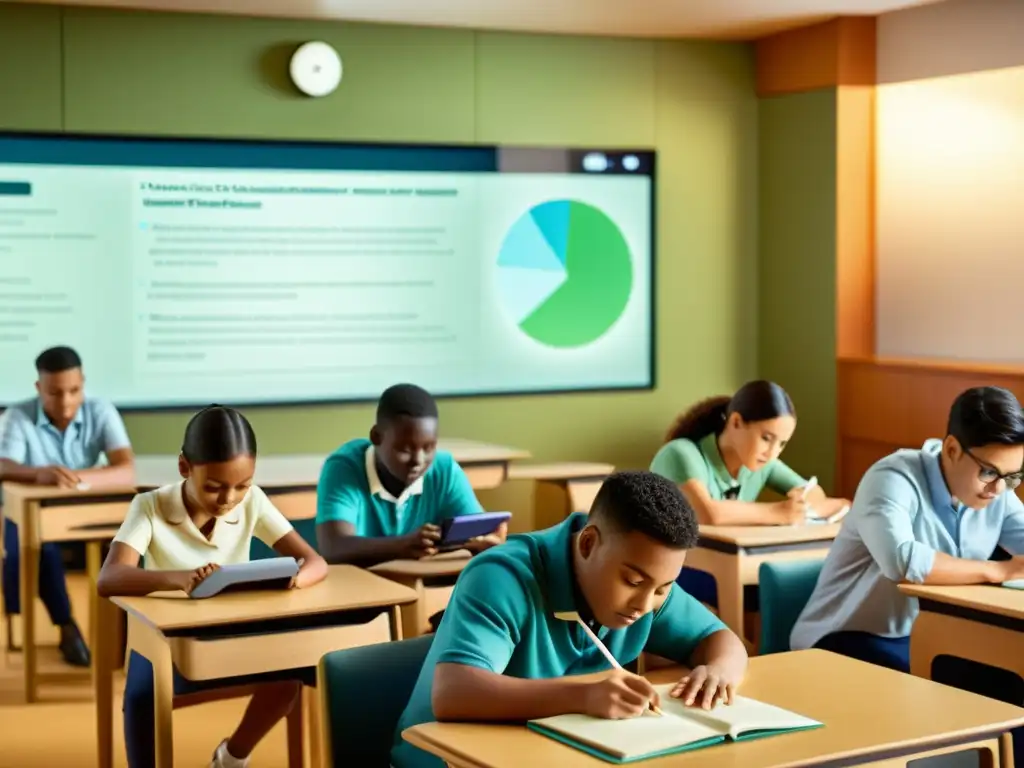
xmin=791 ymin=387 xmax=1024 ymax=765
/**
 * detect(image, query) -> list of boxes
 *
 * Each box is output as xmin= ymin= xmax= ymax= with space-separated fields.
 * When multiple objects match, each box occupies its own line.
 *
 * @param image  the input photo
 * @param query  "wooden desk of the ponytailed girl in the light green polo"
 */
xmin=686 ymin=523 xmax=842 ymax=642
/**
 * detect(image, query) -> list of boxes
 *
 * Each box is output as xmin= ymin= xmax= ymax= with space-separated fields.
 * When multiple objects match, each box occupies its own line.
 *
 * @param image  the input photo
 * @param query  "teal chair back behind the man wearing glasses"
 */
xmin=758 ymin=560 xmax=824 ymax=655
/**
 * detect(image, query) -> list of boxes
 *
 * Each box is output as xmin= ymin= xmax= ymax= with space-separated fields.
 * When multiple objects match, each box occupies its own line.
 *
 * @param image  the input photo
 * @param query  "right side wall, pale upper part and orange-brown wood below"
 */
xmin=839 ymin=0 xmax=1024 ymax=493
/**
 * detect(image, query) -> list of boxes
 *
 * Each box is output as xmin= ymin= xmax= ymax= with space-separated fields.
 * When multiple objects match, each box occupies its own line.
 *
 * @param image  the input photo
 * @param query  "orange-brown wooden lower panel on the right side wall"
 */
xmin=836 ymin=357 xmax=1024 ymax=498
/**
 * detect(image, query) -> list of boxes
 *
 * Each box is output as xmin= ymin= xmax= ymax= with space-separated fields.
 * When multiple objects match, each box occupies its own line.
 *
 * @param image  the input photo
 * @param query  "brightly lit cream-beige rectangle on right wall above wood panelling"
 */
xmin=877 ymin=67 xmax=1024 ymax=362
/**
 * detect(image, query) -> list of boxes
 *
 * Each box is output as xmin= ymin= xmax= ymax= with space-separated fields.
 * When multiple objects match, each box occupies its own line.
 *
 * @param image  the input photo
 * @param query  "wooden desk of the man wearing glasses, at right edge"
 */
xmin=899 ymin=584 xmax=1024 ymax=684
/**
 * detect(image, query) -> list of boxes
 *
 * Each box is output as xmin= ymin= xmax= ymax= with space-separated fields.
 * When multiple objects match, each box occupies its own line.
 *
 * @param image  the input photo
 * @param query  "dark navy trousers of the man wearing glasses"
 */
xmin=815 ymin=632 xmax=1024 ymax=766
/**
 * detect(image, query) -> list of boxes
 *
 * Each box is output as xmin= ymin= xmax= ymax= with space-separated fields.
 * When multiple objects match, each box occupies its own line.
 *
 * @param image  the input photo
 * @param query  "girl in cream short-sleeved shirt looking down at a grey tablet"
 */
xmin=98 ymin=406 xmax=327 ymax=768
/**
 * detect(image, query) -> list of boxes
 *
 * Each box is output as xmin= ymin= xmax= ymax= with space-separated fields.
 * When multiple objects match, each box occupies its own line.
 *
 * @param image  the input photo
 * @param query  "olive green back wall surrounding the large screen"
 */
xmin=0 ymin=2 xmax=761 ymax=483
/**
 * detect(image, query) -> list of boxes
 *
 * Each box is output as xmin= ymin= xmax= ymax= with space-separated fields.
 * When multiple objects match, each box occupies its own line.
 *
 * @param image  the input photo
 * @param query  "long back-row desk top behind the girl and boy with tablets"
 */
xmin=4 ymin=438 xmax=529 ymax=501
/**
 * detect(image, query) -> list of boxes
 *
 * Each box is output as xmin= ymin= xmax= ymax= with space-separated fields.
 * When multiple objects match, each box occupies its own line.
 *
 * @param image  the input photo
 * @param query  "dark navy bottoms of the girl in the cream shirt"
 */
xmin=123 ymin=651 xmax=316 ymax=768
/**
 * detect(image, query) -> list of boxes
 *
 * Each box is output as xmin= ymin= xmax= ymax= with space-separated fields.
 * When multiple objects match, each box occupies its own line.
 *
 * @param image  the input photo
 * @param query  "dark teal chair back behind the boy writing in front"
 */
xmin=316 ymin=635 xmax=433 ymax=768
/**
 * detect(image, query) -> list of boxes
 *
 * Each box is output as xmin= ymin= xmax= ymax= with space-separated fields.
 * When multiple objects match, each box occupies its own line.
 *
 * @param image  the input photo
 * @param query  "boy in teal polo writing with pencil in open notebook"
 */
xmin=391 ymin=472 xmax=746 ymax=768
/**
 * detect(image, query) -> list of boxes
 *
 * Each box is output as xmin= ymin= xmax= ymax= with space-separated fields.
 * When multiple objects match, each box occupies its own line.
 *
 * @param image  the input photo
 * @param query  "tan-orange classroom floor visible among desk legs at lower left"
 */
xmin=0 ymin=574 xmax=296 ymax=768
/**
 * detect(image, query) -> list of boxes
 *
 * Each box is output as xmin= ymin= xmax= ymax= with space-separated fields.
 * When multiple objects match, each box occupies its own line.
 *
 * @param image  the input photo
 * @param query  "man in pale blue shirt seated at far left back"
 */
xmin=0 ymin=347 xmax=135 ymax=667
